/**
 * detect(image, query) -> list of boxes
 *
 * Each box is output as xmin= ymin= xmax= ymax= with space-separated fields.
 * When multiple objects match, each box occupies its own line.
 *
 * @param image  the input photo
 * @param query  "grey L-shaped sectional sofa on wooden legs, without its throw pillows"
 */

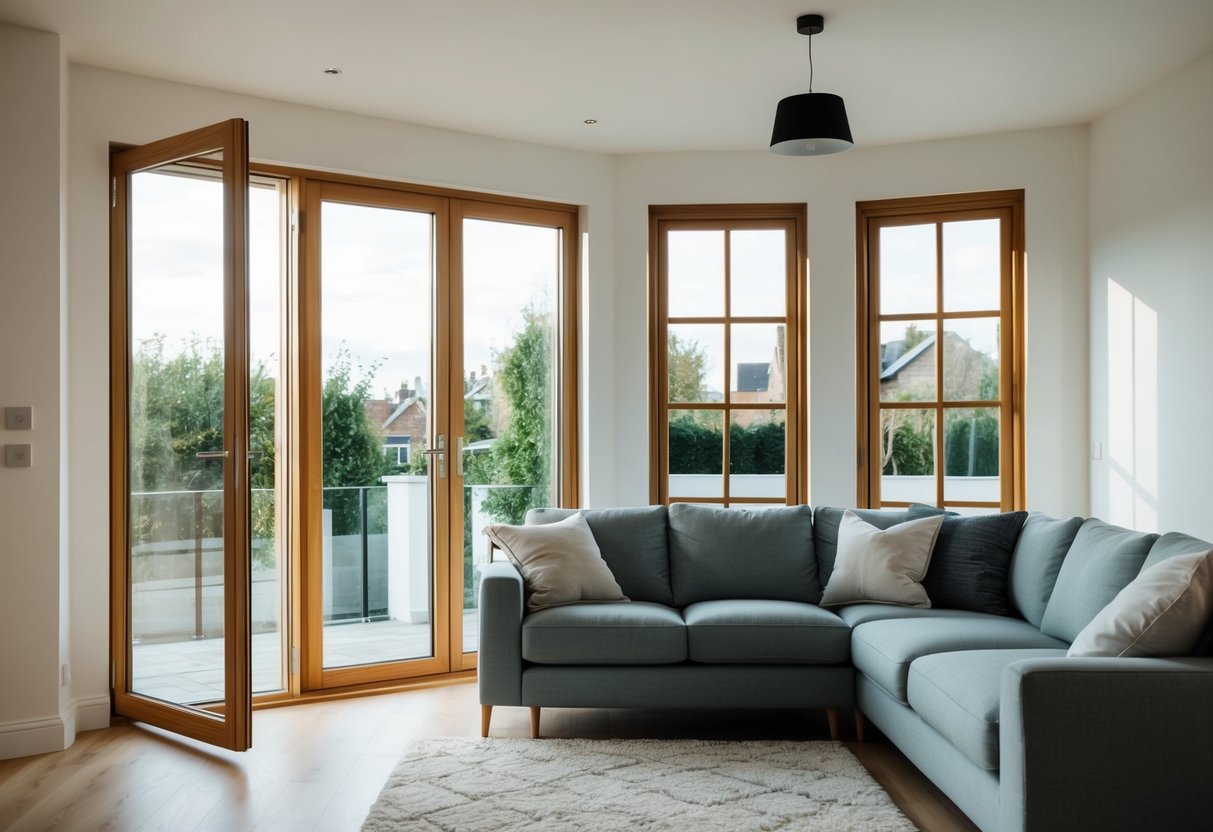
xmin=479 ymin=505 xmax=1213 ymax=832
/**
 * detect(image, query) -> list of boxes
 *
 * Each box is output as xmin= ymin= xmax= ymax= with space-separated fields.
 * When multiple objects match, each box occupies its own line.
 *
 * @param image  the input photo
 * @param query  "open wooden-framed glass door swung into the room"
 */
xmin=110 ymin=119 xmax=252 ymax=751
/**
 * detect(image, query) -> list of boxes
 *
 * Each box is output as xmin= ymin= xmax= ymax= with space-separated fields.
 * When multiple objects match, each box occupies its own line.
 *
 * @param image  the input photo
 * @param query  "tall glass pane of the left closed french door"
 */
xmin=320 ymin=201 xmax=434 ymax=667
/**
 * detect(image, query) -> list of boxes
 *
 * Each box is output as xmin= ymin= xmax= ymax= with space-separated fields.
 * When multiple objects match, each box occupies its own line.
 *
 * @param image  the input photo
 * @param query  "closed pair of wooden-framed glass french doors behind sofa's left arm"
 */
xmin=298 ymin=178 xmax=576 ymax=690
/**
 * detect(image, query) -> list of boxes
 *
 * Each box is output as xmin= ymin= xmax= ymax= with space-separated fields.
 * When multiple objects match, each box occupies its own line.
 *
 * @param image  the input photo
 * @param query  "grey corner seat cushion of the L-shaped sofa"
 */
xmin=850 ymin=612 xmax=1070 ymax=703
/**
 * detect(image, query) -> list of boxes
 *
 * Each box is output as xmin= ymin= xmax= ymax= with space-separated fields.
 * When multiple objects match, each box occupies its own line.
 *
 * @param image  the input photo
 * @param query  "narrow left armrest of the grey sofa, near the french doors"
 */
xmin=477 ymin=560 xmax=523 ymax=705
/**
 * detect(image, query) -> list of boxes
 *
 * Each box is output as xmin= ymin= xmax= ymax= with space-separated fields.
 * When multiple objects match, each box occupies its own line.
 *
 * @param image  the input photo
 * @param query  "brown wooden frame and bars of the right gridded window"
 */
xmin=855 ymin=189 xmax=1026 ymax=511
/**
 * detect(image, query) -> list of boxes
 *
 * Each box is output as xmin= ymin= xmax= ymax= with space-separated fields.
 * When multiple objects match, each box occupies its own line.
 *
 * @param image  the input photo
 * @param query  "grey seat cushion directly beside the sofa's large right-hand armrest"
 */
xmin=906 ymin=649 xmax=1065 ymax=771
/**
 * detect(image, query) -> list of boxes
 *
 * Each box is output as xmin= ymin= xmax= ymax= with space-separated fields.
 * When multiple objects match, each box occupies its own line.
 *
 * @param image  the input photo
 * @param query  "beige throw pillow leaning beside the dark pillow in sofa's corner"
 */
xmin=821 ymin=512 xmax=944 ymax=606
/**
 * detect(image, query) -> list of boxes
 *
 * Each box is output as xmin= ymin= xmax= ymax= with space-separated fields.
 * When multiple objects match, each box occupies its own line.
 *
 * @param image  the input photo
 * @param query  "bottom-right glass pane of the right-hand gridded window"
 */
xmin=944 ymin=408 xmax=1001 ymax=502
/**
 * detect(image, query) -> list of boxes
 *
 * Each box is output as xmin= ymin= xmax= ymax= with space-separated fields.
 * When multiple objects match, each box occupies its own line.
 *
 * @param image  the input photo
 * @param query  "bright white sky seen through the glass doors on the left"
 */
xmin=130 ymin=172 xmax=560 ymax=395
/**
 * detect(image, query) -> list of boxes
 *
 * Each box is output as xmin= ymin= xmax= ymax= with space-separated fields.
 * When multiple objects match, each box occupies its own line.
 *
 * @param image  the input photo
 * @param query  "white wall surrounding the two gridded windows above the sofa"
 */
xmin=615 ymin=125 xmax=1088 ymax=514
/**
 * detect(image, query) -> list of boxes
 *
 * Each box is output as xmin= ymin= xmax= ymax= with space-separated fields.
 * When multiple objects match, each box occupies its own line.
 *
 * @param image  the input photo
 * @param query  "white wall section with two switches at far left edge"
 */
xmin=0 ymin=24 xmax=66 ymax=758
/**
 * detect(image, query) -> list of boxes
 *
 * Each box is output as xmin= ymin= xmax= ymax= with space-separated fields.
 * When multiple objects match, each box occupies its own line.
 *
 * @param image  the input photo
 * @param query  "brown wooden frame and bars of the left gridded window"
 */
xmin=649 ymin=204 xmax=809 ymax=506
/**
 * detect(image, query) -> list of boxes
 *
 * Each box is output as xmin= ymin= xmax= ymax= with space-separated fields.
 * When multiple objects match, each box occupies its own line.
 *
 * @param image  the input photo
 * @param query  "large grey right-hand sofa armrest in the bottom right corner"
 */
xmin=1000 ymin=656 xmax=1213 ymax=832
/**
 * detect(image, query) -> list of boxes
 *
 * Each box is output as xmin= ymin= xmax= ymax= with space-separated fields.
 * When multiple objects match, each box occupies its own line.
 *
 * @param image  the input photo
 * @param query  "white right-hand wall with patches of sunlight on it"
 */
xmin=1090 ymin=53 xmax=1213 ymax=540
